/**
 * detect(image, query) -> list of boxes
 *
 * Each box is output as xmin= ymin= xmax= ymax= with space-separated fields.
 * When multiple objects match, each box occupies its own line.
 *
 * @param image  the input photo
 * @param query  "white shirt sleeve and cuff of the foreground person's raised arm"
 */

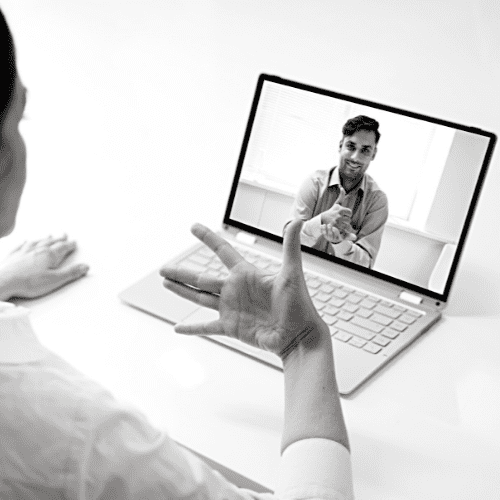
xmin=77 ymin=398 xmax=353 ymax=500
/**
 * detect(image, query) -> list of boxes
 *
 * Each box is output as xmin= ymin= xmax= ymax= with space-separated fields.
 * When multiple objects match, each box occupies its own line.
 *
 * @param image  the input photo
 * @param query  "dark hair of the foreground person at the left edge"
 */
xmin=0 ymin=9 xmax=17 ymax=133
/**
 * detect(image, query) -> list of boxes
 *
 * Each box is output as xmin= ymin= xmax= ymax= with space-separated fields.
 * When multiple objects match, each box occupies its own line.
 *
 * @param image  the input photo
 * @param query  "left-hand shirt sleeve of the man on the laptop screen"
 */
xmin=284 ymin=175 xmax=321 ymax=247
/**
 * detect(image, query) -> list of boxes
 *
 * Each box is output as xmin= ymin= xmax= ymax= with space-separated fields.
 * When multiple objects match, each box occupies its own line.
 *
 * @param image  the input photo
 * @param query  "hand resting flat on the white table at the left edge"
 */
xmin=0 ymin=235 xmax=88 ymax=300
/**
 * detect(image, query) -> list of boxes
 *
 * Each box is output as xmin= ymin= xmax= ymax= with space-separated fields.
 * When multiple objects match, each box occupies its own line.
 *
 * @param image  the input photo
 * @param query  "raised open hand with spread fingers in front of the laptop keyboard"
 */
xmin=160 ymin=219 xmax=330 ymax=359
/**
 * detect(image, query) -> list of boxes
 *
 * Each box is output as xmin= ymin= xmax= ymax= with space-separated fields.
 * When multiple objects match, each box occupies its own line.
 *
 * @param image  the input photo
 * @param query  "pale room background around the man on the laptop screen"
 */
xmin=230 ymin=81 xmax=489 ymax=293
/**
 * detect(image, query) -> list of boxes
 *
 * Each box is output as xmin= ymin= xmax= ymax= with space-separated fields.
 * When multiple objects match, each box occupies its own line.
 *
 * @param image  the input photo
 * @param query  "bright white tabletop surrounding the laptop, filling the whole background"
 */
xmin=0 ymin=0 xmax=500 ymax=500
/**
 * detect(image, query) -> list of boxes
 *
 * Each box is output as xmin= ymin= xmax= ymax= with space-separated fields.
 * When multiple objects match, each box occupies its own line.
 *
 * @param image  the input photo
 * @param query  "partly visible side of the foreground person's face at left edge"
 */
xmin=0 ymin=78 xmax=26 ymax=238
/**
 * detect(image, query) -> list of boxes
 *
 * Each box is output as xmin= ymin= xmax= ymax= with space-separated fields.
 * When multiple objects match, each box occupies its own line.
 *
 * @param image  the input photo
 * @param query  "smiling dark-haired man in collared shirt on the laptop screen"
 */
xmin=285 ymin=115 xmax=389 ymax=268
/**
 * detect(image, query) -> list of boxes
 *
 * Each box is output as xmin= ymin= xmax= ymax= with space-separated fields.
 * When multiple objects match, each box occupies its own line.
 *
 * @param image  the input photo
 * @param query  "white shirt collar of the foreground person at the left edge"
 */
xmin=0 ymin=302 xmax=49 ymax=364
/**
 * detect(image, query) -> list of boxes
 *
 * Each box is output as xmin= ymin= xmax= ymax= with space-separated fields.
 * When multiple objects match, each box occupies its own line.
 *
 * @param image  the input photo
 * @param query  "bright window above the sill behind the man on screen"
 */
xmin=242 ymin=82 xmax=455 ymax=228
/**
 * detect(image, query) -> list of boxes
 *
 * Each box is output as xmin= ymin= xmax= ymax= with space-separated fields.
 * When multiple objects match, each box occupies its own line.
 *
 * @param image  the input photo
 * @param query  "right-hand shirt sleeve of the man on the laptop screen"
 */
xmin=332 ymin=191 xmax=389 ymax=268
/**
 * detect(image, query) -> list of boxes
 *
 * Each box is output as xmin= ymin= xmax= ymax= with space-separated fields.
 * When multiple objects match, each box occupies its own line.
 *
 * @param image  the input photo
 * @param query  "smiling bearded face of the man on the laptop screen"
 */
xmin=339 ymin=130 xmax=377 ymax=186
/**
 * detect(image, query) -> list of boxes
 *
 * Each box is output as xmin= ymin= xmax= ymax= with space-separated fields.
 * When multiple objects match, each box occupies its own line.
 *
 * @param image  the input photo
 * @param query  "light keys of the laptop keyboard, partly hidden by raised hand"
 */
xmin=179 ymin=244 xmax=424 ymax=355
